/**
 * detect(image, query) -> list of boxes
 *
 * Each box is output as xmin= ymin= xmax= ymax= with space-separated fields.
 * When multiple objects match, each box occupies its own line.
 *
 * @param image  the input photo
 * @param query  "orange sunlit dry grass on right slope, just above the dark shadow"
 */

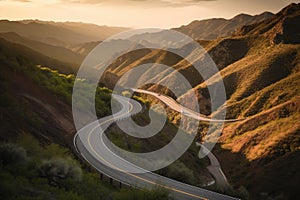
xmin=220 ymin=98 xmax=300 ymax=161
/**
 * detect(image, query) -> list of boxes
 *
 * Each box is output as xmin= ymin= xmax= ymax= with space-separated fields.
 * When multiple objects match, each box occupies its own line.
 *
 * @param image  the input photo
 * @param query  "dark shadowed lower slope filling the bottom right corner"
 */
xmin=213 ymin=145 xmax=300 ymax=200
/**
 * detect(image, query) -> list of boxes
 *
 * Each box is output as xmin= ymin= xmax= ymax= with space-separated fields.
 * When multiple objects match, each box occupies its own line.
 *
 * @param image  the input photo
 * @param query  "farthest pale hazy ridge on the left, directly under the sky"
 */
xmin=0 ymin=20 xmax=128 ymax=46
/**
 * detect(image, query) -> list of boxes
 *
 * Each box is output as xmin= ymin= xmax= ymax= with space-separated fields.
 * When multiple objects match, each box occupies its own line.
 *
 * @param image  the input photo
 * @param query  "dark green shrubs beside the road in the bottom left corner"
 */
xmin=0 ymin=133 xmax=168 ymax=200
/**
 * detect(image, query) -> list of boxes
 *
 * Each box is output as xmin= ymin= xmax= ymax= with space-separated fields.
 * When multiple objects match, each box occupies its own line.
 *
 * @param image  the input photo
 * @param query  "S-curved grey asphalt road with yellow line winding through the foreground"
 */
xmin=74 ymin=95 xmax=236 ymax=200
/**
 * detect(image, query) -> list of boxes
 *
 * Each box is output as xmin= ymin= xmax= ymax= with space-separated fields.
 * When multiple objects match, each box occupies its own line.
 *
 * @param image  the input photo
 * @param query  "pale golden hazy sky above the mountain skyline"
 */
xmin=0 ymin=0 xmax=299 ymax=28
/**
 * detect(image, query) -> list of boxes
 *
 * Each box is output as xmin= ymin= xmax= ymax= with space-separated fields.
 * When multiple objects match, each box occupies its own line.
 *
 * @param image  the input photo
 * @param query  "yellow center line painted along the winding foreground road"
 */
xmin=88 ymin=98 xmax=208 ymax=200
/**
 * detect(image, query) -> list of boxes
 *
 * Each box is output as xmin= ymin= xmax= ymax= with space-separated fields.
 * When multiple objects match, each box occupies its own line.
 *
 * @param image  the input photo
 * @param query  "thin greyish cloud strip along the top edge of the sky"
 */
xmin=61 ymin=0 xmax=216 ymax=7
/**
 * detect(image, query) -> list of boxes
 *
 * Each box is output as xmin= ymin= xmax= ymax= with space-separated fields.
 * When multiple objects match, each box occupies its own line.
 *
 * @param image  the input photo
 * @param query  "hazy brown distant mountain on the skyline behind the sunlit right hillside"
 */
xmin=173 ymin=12 xmax=274 ymax=40
